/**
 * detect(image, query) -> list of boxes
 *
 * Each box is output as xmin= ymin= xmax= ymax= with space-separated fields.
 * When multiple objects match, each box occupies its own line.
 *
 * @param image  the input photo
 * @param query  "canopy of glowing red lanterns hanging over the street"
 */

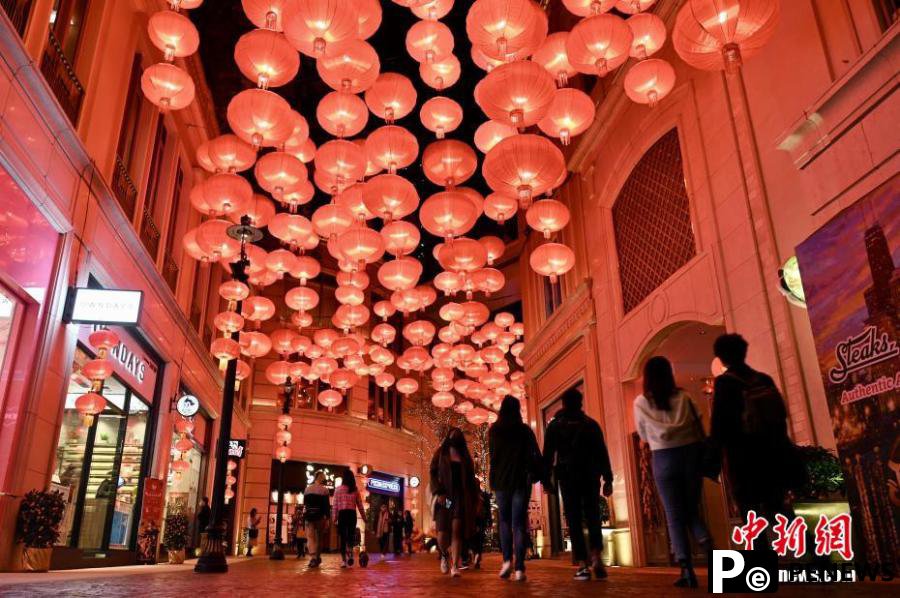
xmin=179 ymin=0 xmax=777 ymax=428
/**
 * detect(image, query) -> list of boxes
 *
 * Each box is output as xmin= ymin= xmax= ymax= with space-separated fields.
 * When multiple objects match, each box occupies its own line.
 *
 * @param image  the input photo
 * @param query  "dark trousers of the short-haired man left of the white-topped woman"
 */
xmin=559 ymin=475 xmax=603 ymax=562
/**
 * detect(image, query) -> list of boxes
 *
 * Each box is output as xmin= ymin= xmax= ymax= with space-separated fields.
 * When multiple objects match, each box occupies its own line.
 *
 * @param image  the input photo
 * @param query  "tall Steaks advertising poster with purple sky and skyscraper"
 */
xmin=797 ymin=177 xmax=900 ymax=571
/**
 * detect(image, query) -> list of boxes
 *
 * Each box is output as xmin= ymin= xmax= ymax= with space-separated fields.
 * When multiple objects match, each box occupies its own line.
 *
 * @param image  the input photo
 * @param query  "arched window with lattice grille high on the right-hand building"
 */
xmin=612 ymin=129 xmax=697 ymax=313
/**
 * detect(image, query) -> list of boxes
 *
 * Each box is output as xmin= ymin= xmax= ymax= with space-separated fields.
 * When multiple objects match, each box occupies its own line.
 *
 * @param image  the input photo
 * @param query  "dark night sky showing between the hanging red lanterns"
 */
xmin=190 ymin=0 xmax=536 ymax=280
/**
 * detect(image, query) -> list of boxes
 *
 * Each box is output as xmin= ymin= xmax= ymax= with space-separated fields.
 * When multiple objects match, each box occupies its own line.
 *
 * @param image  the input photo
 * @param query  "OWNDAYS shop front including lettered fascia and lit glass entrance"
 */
xmin=50 ymin=325 xmax=161 ymax=569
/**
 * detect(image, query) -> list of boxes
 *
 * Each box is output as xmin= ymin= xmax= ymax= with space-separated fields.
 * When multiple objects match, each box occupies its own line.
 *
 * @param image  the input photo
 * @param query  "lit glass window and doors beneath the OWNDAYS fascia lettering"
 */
xmin=52 ymin=347 xmax=150 ymax=551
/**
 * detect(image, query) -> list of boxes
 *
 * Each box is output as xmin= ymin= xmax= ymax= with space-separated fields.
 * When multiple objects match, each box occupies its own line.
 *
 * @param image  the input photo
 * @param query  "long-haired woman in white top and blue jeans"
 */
xmin=634 ymin=357 xmax=712 ymax=588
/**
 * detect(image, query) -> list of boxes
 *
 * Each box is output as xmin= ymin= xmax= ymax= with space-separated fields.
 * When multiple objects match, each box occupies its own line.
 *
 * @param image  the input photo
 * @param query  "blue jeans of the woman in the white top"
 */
xmin=652 ymin=442 xmax=711 ymax=564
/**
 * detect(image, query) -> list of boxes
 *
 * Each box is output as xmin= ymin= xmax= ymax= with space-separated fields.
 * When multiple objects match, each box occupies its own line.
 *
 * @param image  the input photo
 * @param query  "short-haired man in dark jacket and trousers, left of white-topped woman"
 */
xmin=544 ymin=387 xmax=613 ymax=581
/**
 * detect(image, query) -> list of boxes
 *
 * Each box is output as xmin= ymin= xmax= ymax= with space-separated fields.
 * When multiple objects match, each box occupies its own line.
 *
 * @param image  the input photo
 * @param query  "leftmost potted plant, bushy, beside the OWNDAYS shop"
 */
xmin=16 ymin=490 xmax=66 ymax=571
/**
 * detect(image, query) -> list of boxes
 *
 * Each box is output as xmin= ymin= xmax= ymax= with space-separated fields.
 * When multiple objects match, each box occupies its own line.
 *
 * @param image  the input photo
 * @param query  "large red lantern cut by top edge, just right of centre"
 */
xmin=466 ymin=0 xmax=548 ymax=61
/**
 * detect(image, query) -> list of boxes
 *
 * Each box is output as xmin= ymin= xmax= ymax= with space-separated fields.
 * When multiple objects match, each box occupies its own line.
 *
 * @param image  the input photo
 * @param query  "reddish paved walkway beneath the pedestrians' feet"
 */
xmin=0 ymin=555 xmax=888 ymax=598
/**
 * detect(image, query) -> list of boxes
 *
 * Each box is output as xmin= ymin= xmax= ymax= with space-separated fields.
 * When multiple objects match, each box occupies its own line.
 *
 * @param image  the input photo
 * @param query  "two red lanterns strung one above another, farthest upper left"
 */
xmin=141 ymin=0 xmax=202 ymax=111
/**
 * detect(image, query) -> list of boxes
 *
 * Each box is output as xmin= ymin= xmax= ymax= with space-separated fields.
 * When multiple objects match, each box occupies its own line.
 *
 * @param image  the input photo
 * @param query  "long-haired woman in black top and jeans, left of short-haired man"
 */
xmin=487 ymin=396 xmax=544 ymax=581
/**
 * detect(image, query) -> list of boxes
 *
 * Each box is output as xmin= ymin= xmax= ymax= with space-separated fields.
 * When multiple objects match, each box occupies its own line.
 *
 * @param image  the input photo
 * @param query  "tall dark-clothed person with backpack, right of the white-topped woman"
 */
xmin=710 ymin=334 xmax=803 ymax=522
